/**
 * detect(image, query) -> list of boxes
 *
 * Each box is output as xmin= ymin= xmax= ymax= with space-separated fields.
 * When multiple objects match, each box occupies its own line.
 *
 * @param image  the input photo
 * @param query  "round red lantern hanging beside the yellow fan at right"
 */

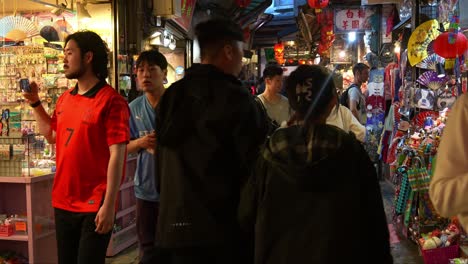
xmin=434 ymin=32 xmax=468 ymax=59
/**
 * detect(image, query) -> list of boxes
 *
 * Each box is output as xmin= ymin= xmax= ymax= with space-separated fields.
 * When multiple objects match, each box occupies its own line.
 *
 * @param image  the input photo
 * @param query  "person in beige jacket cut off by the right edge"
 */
xmin=429 ymin=94 xmax=468 ymax=230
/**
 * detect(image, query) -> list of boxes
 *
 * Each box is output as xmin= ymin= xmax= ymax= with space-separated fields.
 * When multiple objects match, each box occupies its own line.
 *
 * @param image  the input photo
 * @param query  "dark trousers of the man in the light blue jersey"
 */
xmin=136 ymin=198 xmax=159 ymax=259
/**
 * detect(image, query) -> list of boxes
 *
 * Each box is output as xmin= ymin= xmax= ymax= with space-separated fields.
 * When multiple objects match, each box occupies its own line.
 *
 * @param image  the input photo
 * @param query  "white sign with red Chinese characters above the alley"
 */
xmin=335 ymin=7 xmax=379 ymax=32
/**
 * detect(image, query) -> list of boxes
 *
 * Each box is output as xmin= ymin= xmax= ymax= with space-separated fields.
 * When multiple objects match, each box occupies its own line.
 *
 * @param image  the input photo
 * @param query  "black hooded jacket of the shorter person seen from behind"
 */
xmin=239 ymin=125 xmax=393 ymax=264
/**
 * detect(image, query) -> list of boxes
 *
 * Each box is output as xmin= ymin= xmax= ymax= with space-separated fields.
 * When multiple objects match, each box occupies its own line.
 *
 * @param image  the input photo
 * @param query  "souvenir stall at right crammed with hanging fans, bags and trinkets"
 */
xmin=378 ymin=1 xmax=468 ymax=263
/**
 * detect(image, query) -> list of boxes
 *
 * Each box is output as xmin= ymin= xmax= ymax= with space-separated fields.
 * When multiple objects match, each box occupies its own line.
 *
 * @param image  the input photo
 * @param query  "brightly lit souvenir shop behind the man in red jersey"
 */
xmin=0 ymin=0 xmax=142 ymax=263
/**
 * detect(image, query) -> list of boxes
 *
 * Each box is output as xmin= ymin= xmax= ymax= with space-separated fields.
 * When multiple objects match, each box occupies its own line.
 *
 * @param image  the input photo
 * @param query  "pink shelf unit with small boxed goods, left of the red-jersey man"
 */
xmin=0 ymin=173 xmax=57 ymax=263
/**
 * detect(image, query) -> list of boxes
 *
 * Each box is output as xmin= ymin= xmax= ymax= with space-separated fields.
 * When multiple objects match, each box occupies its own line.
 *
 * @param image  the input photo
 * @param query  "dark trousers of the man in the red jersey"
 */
xmin=55 ymin=208 xmax=112 ymax=264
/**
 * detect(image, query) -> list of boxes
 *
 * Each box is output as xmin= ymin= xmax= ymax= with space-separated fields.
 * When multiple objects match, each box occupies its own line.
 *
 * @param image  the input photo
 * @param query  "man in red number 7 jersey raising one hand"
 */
xmin=23 ymin=31 xmax=130 ymax=264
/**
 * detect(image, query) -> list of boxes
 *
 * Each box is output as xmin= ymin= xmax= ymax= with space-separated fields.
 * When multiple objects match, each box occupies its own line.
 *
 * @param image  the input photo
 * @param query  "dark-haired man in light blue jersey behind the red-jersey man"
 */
xmin=127 ymin=50 xmax=167 ymax=260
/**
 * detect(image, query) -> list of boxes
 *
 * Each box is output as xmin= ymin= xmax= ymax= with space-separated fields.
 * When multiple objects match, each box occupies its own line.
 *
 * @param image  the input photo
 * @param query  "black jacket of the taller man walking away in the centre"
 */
xmin=156 ymin=64 xmax=266 ymax=248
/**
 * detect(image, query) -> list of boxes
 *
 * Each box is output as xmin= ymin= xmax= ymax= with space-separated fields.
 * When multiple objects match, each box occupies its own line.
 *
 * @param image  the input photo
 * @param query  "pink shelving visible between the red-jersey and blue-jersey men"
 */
xmin=106 ymin=156 xmax=138 ymax=257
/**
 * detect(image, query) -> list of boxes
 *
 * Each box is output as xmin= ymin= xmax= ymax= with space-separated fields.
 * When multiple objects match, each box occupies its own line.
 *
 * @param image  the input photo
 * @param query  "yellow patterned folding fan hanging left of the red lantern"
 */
xmin=408 ymin=19 xmax=440 ymax=66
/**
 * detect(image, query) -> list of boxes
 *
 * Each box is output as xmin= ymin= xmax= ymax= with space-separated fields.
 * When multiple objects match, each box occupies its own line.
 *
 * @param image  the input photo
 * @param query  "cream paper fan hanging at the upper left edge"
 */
xmin=0 ymin=16 xmax=39 ymax=41
